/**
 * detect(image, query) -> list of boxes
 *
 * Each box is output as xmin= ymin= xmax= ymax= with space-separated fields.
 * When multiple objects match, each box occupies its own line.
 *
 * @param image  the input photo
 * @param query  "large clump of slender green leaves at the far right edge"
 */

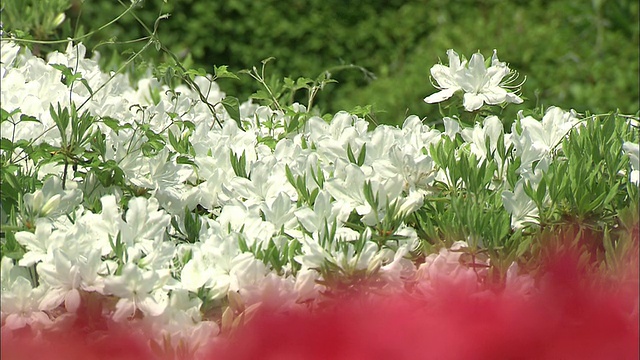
xmin=525 ymin=114 xmax=638 ymax=231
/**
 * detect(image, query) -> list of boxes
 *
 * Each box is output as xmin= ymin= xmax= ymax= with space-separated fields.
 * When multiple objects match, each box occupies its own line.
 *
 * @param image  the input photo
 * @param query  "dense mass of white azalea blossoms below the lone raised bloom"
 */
xmin=1 ymin=42 xmax=637 ymax=354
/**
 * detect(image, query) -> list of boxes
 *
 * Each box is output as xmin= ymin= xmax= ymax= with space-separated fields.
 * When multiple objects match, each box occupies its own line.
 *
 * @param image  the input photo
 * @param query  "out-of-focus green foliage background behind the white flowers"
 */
xmin=3 ymin=0 xmax=640 ymax=124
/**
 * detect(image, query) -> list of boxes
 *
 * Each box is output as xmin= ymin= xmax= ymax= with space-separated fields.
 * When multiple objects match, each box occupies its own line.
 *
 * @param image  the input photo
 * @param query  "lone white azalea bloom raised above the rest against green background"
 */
xmin=424 ymin=49 xmax=522 ymax=111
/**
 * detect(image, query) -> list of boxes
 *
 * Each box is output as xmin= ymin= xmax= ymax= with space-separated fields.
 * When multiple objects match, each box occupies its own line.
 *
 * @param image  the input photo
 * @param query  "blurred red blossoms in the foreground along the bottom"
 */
xmin=2 ymin=249 xmax=639 ymax=360
